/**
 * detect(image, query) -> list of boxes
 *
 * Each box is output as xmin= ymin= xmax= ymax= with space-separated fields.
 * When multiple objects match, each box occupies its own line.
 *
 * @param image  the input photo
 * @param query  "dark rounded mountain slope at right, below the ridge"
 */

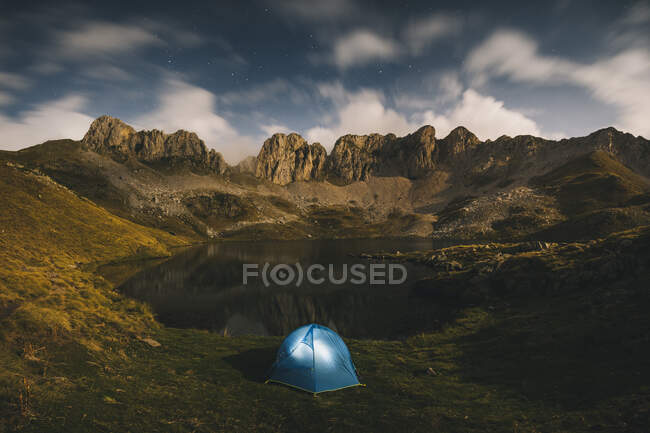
xmin=434 ymin=150 xmax=650 ymax=240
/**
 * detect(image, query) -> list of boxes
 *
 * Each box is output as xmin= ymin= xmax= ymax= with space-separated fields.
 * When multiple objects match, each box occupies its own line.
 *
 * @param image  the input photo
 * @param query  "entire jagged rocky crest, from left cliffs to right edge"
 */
xmin=77 ymin=116 xmax=650 ymax=190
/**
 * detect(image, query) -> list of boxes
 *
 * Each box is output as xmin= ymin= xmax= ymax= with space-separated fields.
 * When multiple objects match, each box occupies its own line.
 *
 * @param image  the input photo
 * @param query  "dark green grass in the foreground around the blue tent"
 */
xmin=11 ymin=284 xmax=650 ymax=432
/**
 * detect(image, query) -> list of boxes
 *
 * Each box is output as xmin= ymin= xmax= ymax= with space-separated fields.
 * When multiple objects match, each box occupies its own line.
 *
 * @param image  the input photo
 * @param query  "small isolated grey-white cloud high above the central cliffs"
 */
xmin=332 ymin=30 xmax=400 ymax=69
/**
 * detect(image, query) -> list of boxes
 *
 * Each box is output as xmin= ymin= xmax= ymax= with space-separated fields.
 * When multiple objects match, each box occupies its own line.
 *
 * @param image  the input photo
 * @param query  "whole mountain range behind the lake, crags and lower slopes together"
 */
xmin=0 ymin=116 xmax=650 ymax=239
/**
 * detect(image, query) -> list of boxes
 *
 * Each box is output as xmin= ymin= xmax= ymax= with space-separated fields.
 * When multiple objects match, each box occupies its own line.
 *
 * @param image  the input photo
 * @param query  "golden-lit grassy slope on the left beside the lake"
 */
xmin=0 ymin=162 xmax=186 ymax=426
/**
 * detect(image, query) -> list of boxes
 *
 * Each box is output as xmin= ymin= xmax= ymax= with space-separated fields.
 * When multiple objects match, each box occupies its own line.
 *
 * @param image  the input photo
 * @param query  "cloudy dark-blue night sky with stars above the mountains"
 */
xmin=0 ymin=0 xmax=650 ymax=163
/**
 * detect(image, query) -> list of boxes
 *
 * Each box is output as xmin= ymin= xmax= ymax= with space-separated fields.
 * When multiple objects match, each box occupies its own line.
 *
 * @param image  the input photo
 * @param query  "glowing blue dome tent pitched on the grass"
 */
xmin=267 ymin=324 xmax=361 ymax=394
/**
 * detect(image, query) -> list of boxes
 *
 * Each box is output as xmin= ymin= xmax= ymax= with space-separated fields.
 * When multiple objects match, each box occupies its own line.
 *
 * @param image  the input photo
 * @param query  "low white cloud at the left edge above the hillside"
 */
xmin=0 ymin=94 xmax=93 ymax=150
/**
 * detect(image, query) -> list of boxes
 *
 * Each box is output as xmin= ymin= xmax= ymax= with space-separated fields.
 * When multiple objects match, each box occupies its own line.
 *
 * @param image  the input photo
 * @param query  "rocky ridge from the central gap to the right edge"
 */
xmin=255 ymin=125 xmax=650 ymax=185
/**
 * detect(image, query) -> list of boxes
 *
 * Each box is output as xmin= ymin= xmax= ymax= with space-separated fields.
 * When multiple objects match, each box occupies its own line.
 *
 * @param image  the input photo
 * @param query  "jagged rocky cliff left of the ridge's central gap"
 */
xmin=82 ymin=116 xmax=228 ymax=174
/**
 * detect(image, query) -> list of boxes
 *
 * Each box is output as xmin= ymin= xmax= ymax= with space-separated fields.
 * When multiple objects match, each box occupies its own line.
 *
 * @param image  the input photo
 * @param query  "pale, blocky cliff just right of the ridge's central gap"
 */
xmin=255 ymin=133 xmax=327 ymax=185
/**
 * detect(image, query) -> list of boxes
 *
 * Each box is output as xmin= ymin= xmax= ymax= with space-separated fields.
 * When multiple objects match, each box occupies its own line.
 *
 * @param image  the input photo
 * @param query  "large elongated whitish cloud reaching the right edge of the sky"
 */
xmin=465 ymin=30 xmax=650 ymax=137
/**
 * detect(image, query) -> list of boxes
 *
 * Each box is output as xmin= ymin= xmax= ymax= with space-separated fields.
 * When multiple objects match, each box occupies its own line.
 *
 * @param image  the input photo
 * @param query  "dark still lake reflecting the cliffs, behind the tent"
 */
xmin=121 ymin=240 xmax=454 ymax=338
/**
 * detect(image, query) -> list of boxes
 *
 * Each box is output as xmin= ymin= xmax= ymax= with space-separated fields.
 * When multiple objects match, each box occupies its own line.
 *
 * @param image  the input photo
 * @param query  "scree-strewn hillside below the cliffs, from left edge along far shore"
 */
xmin=0 ymin=136 xmax=431 ymax=240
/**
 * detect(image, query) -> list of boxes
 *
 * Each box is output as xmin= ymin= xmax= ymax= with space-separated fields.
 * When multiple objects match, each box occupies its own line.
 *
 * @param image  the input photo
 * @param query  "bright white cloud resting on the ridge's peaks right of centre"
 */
xmin=414 ymin=89 xmax=542 ymax=140
